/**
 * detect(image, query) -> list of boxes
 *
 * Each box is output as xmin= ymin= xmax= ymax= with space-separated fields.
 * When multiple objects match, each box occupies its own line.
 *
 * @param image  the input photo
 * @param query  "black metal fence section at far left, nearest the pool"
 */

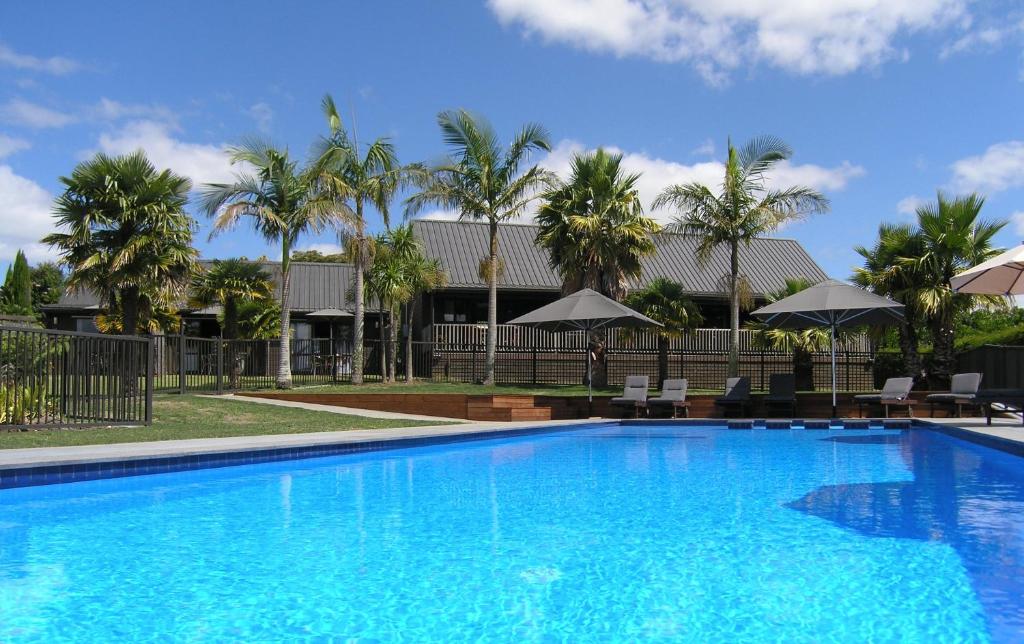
xmin=0 ymin=327 xmax=154 ymax=428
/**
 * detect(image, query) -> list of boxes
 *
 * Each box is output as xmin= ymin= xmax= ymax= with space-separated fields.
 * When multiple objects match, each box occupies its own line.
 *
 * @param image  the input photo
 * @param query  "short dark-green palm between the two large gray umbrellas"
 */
xmin=626 ymin=277 xmax=703 ymax=382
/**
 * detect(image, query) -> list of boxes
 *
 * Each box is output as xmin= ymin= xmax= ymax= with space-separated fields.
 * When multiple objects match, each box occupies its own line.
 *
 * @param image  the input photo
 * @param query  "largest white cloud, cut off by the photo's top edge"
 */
xmin=488 ymin=0 xmax=968 ymax=84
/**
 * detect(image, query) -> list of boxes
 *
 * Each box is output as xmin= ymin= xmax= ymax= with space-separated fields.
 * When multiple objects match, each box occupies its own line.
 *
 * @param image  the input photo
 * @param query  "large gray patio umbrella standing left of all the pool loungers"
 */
xmin=508 ymin=289 xmax=662 ymax=401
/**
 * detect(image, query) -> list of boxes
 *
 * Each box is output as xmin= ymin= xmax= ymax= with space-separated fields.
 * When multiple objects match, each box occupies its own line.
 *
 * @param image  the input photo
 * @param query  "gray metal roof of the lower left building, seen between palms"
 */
xmin=43 ymin=260 xmax=371 ymax=313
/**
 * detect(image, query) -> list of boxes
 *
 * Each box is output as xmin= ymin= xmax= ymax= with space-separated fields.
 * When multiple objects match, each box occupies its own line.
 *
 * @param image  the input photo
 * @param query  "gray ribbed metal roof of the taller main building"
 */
xmin=413 ymin=219 xmax=828 ymax=297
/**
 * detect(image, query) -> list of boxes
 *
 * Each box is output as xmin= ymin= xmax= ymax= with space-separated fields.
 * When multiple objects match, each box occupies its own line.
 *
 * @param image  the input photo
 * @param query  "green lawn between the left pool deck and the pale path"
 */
xmin=0 ymin=394 xmax=444 ymax=449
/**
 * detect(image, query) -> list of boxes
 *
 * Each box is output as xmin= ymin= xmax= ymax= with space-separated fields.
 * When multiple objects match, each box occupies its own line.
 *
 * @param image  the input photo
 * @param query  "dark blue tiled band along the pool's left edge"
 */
xmin=0 ymin=420 xmax=615 ymax=489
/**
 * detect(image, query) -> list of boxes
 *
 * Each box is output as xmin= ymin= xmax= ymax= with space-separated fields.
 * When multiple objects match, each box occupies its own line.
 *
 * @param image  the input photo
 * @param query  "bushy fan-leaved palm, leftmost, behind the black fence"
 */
xmin=43 ymin=151 xmax=197 ymax=335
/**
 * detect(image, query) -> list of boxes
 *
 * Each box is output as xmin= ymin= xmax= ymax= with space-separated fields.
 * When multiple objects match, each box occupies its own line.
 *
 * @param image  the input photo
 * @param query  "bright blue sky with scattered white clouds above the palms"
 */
xmin=0 ymin=0 xmax=1024 ymax=277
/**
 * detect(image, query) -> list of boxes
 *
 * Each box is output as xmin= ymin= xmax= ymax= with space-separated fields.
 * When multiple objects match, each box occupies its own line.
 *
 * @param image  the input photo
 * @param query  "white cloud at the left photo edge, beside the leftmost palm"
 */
xmin=0 ymin=165 xmax=56 ymax=262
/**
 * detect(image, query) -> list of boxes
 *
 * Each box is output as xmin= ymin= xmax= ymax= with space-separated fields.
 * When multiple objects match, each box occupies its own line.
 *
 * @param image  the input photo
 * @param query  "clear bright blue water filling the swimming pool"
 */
xmin=0 ymin=425 xmax=1024 ymax=642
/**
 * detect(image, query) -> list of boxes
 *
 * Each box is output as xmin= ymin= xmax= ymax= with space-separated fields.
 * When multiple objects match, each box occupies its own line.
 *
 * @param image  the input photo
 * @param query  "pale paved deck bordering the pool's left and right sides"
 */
xmin=0 ymin=409 xmax=1024 ymax=470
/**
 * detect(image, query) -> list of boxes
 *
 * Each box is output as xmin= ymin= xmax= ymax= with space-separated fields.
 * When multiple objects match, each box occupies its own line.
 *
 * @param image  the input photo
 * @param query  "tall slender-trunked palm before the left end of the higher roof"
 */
xmin=407 ymin=110 xmax=554 ymax=385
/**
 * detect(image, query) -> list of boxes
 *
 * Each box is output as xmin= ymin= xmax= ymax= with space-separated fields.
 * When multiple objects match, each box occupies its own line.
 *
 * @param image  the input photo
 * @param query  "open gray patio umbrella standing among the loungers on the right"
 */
xmin=752 ymin=280 xmax=903 ymax=418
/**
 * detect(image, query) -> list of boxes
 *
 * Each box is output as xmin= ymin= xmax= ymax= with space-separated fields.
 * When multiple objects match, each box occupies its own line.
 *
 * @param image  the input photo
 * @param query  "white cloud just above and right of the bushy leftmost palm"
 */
xmin=99 ymin=121 xmax=234 ymax=187
